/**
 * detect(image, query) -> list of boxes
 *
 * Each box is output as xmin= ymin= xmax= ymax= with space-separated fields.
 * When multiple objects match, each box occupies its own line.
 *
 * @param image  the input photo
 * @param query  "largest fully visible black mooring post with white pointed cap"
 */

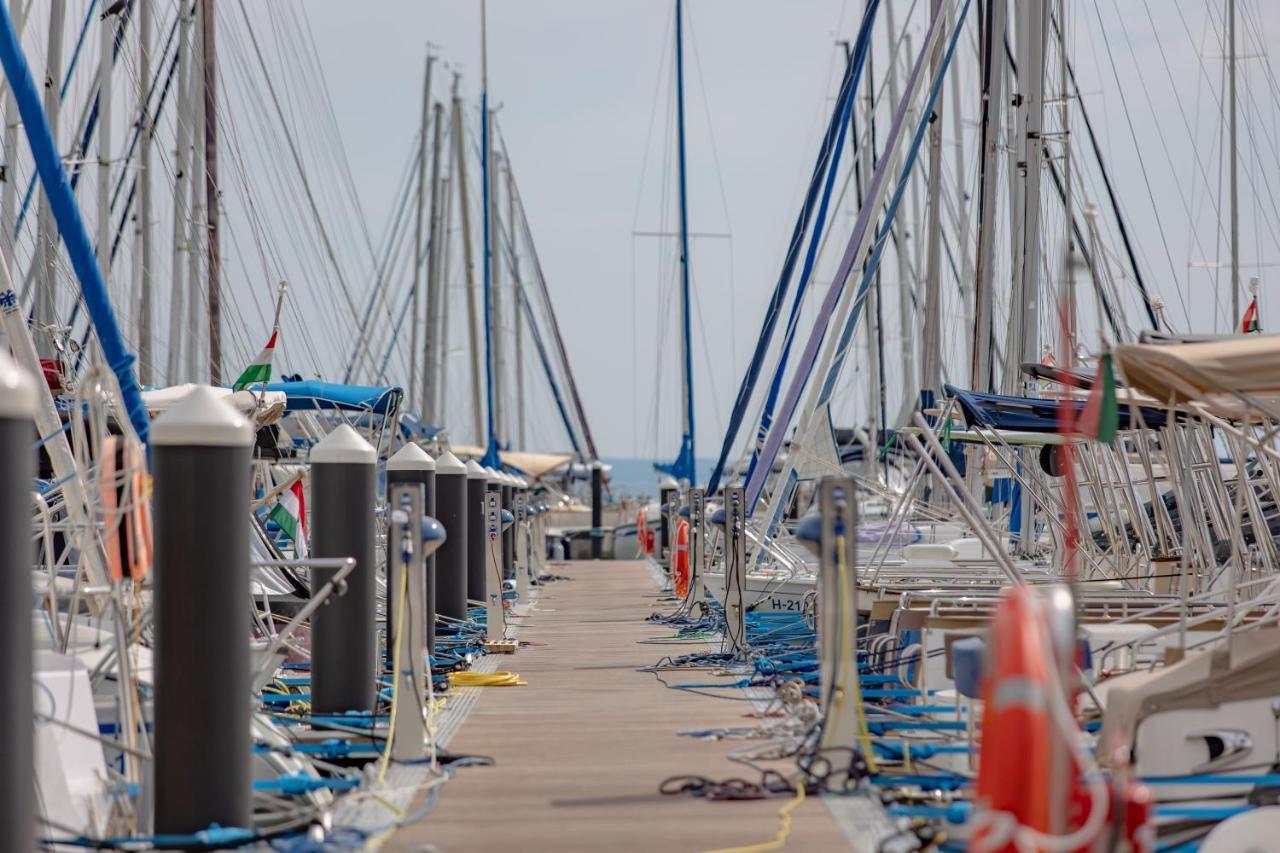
xmin=152 ymin=387 xmax=253 ymax=835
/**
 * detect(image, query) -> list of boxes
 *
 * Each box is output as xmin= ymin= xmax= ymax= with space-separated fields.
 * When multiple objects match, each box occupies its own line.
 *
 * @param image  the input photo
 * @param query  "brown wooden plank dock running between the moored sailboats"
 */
xmin=383 ymin=561 xmax=850 ymax=853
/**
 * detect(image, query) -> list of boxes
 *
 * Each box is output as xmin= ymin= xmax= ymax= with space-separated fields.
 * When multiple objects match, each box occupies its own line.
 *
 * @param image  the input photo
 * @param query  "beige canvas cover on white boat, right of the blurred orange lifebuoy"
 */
xmin=1098 ymin=628 xmax=1280 ymax=756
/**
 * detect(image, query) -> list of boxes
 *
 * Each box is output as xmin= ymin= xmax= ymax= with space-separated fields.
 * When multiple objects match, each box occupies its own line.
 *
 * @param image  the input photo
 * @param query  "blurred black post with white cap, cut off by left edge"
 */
xmin=0 ymin=350 xmax=35 ymax=850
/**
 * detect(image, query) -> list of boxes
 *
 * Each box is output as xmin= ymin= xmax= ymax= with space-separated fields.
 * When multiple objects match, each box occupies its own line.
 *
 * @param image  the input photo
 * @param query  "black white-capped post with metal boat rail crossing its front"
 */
xmin=311 ymin=424 xmax=378 ymax=713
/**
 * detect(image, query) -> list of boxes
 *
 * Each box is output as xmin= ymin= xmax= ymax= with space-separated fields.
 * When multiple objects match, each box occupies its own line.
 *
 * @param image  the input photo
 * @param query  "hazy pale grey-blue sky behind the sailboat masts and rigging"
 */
xmin=15 ymin=0 xmax=1280 ymax=457
